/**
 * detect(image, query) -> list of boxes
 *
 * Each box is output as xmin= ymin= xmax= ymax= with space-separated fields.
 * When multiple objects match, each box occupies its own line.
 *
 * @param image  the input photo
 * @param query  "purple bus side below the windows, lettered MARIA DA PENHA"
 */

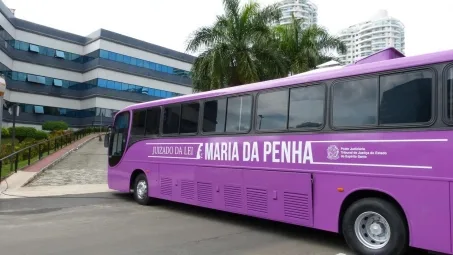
xmin=108 ymin=131 xmax=453 ymax=252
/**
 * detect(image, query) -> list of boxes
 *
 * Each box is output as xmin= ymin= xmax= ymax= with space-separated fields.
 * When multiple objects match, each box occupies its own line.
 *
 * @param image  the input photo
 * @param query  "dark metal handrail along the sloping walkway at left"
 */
xmin=0 ymin=127 xmax=106 ymax=181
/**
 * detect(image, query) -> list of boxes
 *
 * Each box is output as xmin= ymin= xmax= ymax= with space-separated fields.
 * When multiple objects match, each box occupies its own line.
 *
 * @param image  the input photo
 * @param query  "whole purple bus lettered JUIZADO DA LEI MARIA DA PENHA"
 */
xmin=105 ymin=48 xmax=453 ymax=255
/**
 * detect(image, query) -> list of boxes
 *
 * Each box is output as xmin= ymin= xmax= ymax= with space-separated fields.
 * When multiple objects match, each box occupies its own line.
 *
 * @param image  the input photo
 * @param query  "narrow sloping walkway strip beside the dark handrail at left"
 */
xmin=0 ymin=134 xmax=99 ymax=198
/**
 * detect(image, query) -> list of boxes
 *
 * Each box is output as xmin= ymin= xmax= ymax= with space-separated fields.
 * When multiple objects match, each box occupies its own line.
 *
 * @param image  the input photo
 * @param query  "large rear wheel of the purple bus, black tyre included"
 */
xmin=342 ymin=198 xmax=408 ymax=255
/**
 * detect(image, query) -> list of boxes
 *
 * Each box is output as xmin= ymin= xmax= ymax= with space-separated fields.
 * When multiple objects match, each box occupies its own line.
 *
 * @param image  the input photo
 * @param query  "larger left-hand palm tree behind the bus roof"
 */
xmin=187 ymin=0 xmax=288 ymax=91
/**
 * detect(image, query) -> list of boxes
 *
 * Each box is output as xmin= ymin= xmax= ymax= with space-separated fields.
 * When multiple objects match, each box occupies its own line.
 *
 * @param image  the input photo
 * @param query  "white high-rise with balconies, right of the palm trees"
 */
xmin=339 ymin=10 xmax=405 ymax=64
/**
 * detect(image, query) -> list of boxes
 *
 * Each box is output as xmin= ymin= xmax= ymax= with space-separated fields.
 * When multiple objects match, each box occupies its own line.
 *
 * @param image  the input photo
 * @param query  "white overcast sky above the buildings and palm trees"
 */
xmin=3 ymin=0 xmax=453 ymax=56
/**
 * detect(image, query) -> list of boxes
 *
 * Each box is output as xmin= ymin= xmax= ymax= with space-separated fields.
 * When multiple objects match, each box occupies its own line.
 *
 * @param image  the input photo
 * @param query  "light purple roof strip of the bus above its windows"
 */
xmin=118 ymin=48 xmax=453 ymax=113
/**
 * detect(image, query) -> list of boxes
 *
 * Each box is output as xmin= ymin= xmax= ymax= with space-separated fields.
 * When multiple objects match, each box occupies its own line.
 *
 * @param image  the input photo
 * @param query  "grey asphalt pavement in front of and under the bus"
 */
xmin=0 ymin=193 xmax=438 ymax=255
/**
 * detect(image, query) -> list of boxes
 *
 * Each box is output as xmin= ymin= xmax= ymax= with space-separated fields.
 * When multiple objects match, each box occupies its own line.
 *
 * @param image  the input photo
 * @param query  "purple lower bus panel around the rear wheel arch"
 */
xmin=313 ymin=174 xmax=451 ymax=252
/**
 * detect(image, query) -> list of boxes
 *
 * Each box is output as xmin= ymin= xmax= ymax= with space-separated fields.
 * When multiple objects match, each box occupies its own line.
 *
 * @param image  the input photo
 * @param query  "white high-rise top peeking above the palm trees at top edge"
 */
xmin=279 ymin=0 xmax=318 ymax=28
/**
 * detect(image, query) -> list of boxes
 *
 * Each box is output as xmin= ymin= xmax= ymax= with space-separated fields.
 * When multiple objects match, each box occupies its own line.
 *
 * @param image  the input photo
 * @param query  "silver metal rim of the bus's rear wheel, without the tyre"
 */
xmin=354 ymin=212 xmax=391 ymax=250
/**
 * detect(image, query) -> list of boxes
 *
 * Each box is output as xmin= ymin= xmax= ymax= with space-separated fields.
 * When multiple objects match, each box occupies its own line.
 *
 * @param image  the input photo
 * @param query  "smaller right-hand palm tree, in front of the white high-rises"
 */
xmin=274 ymin=15 xmax=346 ymax=74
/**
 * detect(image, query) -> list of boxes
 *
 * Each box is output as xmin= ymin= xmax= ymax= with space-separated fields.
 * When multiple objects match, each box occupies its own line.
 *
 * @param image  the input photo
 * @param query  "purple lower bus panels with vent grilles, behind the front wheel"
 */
xmin=150 ymin=164 xmax=313 ymax=226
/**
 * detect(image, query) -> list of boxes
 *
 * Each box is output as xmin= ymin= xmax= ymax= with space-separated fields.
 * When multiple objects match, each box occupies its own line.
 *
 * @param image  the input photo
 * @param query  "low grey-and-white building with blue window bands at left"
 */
xmin=0 ymin=1 xmax=195 ymax=128
